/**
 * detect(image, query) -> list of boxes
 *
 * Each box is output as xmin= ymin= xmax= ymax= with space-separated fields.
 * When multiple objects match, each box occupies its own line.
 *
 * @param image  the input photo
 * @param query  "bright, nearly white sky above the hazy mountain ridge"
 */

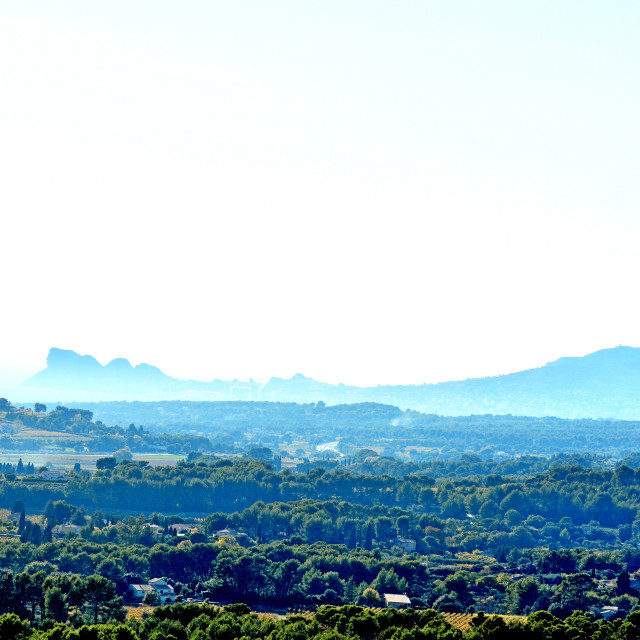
xmin=0 ymin=0 xmax=640 ymax=385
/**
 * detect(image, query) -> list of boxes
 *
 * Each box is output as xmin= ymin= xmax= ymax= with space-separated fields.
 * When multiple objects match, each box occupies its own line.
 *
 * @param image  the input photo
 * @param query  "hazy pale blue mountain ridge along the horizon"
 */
xmin=23 ymin=346 xmax=640 ymax=420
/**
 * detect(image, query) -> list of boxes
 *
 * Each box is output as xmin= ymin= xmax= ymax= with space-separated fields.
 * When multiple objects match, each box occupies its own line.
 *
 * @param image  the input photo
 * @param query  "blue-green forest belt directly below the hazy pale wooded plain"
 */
xmin=0 ymin=456 xmax=639 ymax=527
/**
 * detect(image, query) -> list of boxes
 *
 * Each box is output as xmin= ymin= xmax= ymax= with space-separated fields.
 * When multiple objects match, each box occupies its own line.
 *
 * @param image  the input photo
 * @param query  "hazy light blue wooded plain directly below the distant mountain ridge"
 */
xmin=8 ymin=398 xmax=640 ymax=462
